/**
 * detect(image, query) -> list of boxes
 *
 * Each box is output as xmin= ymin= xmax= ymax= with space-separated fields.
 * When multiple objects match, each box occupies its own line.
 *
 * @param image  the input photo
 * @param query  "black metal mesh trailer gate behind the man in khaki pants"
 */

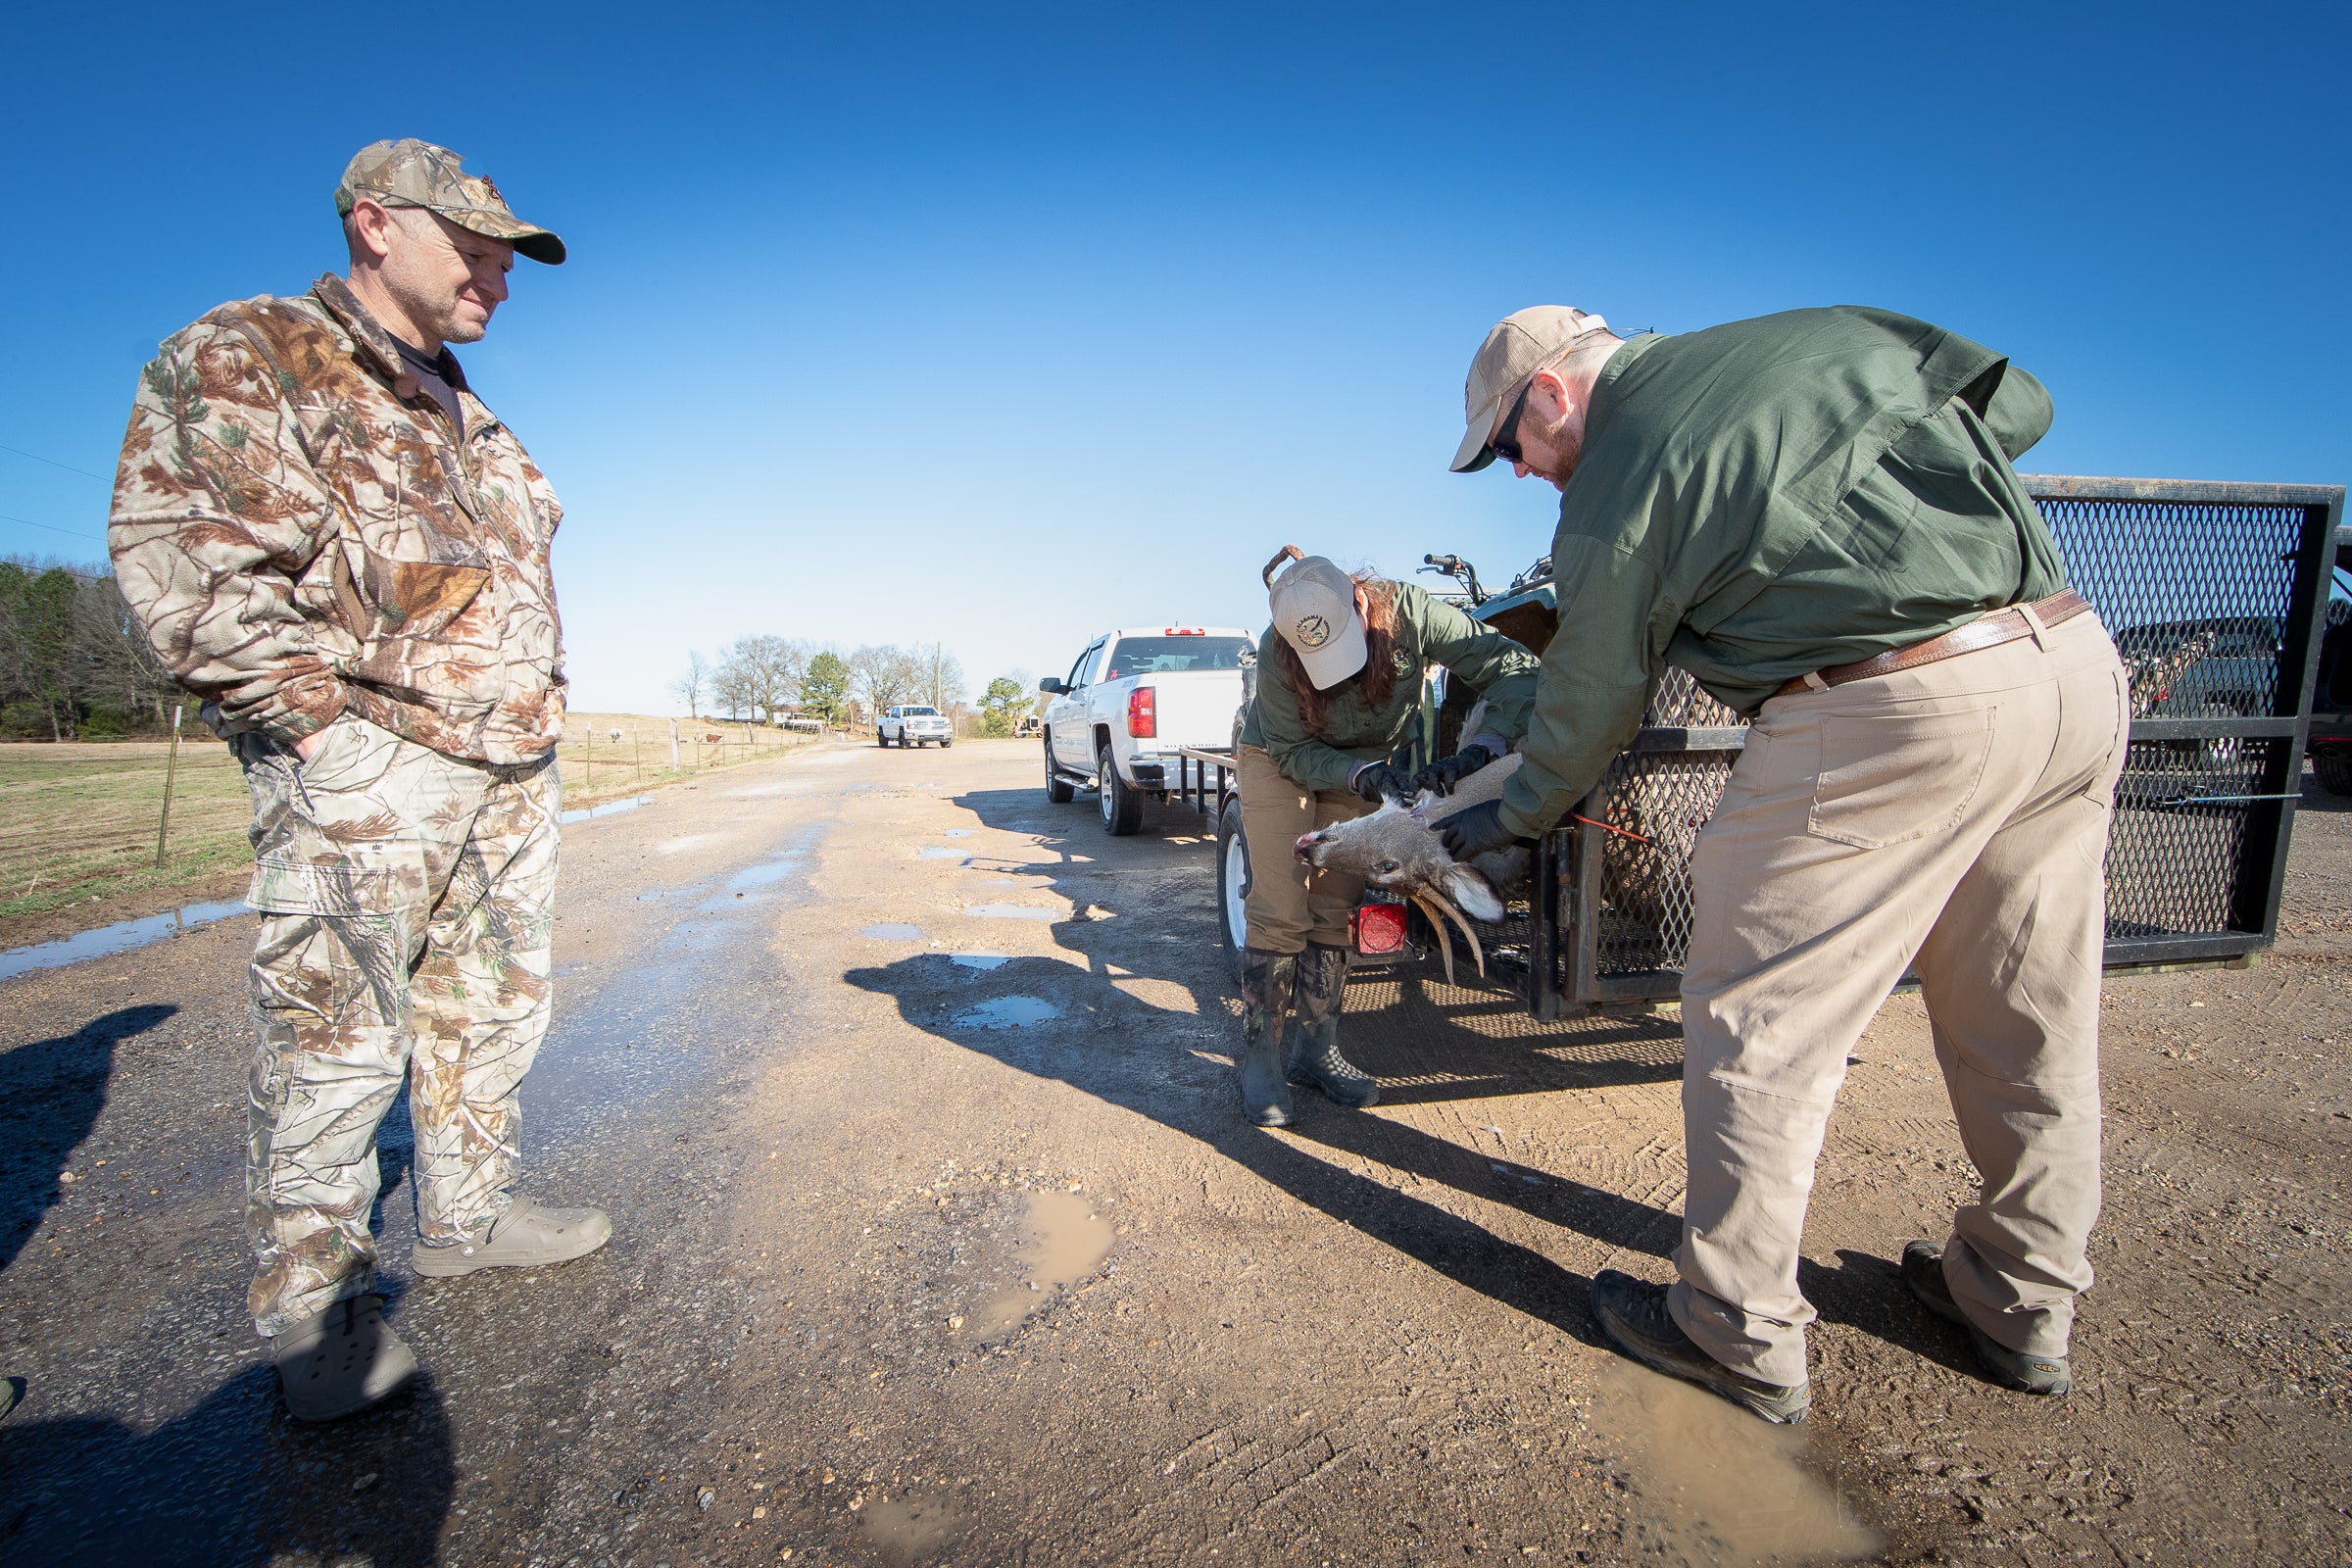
xmin=1430 ymin=475 xmax=2347 ymax=1020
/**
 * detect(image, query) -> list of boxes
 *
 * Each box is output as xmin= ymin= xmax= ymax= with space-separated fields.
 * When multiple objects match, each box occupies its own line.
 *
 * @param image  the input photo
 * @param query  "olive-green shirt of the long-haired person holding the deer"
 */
xmin=1242 ymin=583 xmax=1541 ymax=790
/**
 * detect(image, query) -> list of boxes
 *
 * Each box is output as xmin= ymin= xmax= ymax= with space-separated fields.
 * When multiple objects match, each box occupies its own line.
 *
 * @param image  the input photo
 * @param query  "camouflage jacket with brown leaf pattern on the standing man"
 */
xmin=108 ymin=275 xmax=564 ymax=764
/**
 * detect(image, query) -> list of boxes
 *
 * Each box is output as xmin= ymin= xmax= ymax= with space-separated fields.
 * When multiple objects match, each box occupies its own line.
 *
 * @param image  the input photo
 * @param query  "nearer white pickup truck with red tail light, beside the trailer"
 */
xmin=1037 ymin=625 xmax=1258 ymax=837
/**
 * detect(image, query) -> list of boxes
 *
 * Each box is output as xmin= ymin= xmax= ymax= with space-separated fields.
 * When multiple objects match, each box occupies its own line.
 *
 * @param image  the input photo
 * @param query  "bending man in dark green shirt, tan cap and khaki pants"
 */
xmin=1446 ymin=306 xmax=2129 ymax=1420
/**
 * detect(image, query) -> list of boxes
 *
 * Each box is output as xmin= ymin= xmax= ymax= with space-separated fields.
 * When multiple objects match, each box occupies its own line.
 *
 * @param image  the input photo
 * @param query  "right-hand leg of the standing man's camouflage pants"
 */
xmin=410 ymin=764 xmax=563 ymax=1242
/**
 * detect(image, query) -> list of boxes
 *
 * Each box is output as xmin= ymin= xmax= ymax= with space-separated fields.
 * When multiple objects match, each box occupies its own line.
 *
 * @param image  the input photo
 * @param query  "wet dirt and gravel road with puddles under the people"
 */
xmin=0 ymin=743 xmax=2352 ymax=1568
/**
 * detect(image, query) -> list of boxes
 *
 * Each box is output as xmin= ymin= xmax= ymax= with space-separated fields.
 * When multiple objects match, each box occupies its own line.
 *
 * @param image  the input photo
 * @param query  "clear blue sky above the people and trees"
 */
xmin=0 ymin=5 xmax=2352 ymax=712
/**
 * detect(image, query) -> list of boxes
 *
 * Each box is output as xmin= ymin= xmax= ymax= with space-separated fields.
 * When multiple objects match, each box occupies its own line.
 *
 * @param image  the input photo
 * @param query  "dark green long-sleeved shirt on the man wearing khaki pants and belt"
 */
xmin=1503 ymin=306 xmax=2065 ymax=835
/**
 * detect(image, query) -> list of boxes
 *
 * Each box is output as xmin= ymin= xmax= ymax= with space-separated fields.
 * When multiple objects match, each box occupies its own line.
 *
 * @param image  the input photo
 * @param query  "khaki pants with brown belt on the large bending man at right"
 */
xmin=1668 ymin=613 xmax=2131 ymax=1385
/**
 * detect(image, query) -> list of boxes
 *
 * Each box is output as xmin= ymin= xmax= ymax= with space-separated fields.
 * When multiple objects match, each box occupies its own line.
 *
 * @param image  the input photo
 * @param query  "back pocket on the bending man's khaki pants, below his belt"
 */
xmin=1806 ymin=708 xmax=1997 ymax=849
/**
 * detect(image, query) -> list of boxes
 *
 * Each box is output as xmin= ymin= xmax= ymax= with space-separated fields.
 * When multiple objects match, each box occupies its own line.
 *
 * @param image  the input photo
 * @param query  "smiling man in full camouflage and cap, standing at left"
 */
xmin=108 ymin=141 xmax=612 ymax=1420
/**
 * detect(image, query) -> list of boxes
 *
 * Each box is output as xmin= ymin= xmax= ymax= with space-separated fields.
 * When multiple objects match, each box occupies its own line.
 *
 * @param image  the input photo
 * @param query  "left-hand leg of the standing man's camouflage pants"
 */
xmin=237 ymin=717 xmax=492 ymax=1336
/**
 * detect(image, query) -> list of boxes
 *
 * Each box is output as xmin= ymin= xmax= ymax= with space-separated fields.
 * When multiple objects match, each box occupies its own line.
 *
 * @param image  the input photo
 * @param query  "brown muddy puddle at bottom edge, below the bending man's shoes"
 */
xmin=1592 ymin=1363 xmax=1880 ymax=1568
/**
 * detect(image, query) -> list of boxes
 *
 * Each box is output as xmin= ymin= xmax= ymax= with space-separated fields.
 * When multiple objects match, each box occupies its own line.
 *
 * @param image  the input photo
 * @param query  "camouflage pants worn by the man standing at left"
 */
xmin=237 ymin=714 xmax=560 ymax=1336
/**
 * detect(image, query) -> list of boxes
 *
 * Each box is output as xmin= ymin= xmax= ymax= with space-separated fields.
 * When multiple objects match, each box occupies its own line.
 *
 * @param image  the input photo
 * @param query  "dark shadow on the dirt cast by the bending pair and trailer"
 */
xmin=845 ymin=790 xmax=1712 ymax=1343
